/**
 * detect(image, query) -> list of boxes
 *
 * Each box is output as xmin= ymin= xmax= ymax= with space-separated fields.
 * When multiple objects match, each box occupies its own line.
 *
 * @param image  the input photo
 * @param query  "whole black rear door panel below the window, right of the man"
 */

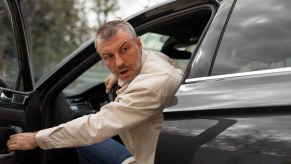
xmin=156 ymin=69 xmax=291 ymax=164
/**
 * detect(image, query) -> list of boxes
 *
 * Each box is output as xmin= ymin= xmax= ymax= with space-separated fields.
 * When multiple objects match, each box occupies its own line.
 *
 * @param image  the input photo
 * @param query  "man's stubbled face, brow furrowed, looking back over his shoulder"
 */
xmin=97 ymin=30 xmax=142 ymax=82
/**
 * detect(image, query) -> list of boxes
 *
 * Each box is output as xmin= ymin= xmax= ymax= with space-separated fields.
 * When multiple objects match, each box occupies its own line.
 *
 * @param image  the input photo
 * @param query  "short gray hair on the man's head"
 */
xmin=95 ymin=20 xmax=137 ymax=49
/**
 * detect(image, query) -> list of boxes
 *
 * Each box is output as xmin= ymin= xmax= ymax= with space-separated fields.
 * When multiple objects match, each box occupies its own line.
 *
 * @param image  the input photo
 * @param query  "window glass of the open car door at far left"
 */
xmin=0 ymin=1 xmax=19 ymax=88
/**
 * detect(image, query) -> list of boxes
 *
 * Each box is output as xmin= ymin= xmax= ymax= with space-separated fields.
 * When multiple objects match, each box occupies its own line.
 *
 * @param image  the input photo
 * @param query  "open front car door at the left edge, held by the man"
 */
xmin=0 ymin=0 xmax=38 ymax=164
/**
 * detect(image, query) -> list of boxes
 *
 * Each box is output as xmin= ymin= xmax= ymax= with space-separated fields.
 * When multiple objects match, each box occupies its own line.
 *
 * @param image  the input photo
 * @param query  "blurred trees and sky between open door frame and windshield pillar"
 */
xmin=25 ymin=0 xmax=119 ymax=81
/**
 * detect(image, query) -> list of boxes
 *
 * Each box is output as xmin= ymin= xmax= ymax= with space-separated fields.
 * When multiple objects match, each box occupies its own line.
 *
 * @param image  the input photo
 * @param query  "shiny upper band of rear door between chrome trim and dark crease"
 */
xmin=170 ymin=70 xmax=291 ymax=112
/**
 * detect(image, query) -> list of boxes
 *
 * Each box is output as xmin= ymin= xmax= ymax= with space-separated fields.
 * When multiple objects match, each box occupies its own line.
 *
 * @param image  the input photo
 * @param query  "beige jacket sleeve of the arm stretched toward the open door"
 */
xmin=36 ymin=87 xmax=163 ymax=149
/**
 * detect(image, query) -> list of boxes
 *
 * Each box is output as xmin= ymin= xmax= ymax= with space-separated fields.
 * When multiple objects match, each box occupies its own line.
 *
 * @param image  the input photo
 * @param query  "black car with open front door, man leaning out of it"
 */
xmin=0 ymin=0 xmax=291 ymax=164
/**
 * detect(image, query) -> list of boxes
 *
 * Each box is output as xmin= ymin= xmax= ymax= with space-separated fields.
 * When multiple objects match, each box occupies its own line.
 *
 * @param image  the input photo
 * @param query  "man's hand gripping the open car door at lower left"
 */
xmin=7 ymin=132 xmax=38 ymax=151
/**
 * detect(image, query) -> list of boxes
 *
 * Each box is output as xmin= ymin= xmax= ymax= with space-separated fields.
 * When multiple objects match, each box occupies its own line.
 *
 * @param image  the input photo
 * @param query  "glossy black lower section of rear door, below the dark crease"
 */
xmin=155 ymin=113 xmax=291 ymax=164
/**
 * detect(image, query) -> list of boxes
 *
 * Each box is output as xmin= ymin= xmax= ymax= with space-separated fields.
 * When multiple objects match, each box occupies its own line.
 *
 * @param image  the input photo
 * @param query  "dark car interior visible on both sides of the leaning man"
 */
xmin=61 ymin=4 xmax=213 ymax=122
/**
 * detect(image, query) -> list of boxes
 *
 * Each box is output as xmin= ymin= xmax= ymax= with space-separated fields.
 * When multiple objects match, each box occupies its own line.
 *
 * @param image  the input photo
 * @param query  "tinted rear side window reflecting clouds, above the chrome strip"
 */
xmin=212 ymin=0 xmax=291 ymax=75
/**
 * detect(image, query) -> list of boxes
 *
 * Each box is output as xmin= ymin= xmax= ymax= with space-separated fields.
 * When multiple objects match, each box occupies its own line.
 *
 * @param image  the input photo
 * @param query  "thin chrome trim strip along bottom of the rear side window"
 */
xmin=185 ymin=67 xmax=291 ymax=83
